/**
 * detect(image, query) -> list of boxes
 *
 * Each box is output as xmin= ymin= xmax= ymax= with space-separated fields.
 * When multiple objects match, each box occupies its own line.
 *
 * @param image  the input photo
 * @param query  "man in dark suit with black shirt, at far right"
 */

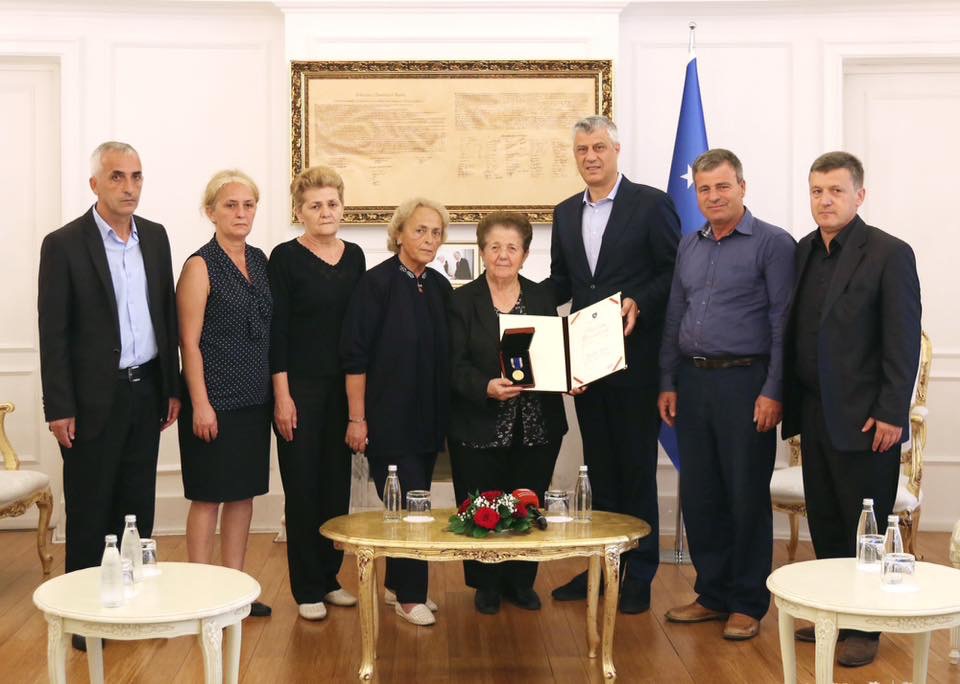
xmin=783 ymin=152 xmax=921 ymax=667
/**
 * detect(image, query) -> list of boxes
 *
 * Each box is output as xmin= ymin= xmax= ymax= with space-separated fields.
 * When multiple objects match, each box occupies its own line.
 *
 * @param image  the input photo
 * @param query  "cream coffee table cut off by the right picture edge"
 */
xmin=767 ymin=558 xmax=960 ymax=684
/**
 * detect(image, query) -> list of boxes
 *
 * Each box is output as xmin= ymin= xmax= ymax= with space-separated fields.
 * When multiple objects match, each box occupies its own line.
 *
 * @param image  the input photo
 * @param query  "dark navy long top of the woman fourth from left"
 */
xmin=340 ymin=256 xmax=453 ymax=455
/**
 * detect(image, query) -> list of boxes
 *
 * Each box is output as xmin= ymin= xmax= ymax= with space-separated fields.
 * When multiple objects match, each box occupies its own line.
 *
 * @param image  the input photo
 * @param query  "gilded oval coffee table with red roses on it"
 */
xmin=320 ymin=509 xmax=650 ymax=680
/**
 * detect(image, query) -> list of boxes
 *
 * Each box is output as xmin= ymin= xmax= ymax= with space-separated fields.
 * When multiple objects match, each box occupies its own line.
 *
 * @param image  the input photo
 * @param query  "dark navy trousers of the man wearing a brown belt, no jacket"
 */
xmin=677 ymin=363 xmax=777 ymax=620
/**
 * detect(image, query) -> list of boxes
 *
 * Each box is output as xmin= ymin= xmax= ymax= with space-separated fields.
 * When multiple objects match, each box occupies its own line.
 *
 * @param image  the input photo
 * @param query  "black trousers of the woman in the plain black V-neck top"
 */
xmin=277 ymin=377 xmax=350 ymax=603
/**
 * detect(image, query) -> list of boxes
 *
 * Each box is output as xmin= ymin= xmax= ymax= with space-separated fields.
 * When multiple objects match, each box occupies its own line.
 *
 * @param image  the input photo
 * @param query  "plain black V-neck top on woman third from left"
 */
xmin=269 ymin=239 xmax=367 ymax=380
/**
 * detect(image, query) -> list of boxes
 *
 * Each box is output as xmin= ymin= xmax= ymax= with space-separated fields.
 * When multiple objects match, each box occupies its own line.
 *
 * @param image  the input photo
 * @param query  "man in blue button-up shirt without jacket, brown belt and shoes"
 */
xmin=658 ymin=149 xmax=796 ymax=640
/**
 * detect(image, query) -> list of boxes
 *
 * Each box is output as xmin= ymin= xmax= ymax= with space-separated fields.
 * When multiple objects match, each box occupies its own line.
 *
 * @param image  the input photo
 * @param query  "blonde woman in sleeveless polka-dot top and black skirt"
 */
xmin=177 ymin=170 xmax=273 ymax=616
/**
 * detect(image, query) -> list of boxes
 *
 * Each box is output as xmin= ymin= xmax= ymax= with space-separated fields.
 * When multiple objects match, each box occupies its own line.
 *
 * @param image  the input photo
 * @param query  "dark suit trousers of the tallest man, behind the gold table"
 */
xmin=575 ymin=381 xmax=660 ymax=592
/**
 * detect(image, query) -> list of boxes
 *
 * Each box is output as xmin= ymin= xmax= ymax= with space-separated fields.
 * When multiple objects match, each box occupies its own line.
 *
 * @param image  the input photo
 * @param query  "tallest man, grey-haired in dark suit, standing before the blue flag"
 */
xmin=549 ymin=116 xmax=680 ymax=613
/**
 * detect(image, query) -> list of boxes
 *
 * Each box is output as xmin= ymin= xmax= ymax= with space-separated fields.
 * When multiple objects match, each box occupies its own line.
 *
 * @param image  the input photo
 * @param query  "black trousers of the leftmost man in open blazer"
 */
xmin=60 ymin=377 xmax=164 ymax=572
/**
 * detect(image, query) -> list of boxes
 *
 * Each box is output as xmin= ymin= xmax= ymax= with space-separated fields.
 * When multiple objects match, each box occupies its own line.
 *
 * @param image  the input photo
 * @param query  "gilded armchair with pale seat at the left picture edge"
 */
xmin=0 ymin=402 xmax=53 ymax=575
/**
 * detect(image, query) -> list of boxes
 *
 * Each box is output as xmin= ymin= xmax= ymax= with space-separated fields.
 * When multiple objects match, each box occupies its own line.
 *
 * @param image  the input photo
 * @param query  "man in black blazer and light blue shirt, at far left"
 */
xmin=37 ymin=142 xmax=180 ymax=588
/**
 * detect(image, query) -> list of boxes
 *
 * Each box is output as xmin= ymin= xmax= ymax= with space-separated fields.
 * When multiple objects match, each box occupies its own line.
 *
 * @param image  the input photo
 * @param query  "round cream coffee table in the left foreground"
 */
xmin=33 ymin=563 xmax=260 ymax=684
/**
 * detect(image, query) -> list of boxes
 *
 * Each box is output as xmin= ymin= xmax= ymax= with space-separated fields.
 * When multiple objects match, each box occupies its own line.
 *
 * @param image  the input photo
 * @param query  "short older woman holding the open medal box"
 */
xmin=448 ymin=212 xmax=567 ymax=614
